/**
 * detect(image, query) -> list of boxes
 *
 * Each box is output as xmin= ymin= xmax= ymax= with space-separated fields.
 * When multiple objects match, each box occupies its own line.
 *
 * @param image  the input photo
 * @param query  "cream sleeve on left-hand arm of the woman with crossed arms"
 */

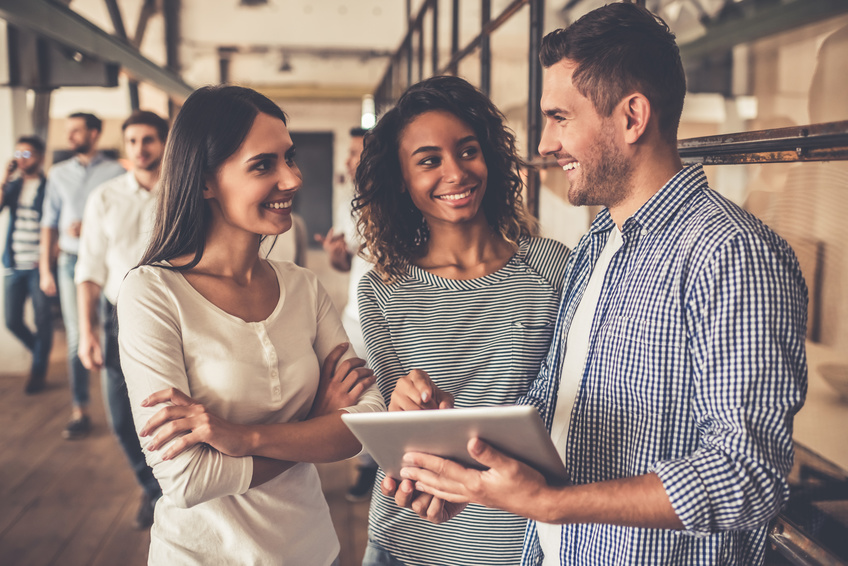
xmin=118 ymin=267 xmax=253 ymax=508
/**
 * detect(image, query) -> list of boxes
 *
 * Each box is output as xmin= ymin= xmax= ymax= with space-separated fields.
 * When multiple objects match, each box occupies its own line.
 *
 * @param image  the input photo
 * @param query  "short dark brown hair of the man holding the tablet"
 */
xmin=539 ymin=2 xmax=686 ymax=141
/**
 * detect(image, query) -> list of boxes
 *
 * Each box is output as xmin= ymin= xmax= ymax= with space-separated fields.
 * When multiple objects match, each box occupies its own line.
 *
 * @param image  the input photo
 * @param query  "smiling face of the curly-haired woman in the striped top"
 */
xmin=398 ymin=110 xmax=488 ymax=229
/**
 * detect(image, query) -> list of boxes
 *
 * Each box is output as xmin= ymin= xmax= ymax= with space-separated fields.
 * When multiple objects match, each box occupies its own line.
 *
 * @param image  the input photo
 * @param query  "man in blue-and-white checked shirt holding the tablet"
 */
xmin=394 ymin=3 xmax=807 ymax=566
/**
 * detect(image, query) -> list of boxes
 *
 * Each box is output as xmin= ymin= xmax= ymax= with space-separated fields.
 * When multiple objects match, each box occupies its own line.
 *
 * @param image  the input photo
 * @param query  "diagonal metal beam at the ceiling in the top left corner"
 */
xmin=0 ymin=0 xmax=194 ymax=102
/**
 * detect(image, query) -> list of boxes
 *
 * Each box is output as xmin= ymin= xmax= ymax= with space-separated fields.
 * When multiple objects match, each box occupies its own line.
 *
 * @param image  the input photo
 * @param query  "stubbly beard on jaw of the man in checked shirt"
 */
xmin=568 ymin=122 xmax=633 ymax=208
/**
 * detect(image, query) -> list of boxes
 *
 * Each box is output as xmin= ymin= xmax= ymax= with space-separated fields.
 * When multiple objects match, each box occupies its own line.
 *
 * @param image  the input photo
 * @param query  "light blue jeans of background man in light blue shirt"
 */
xmin=57 ymin=252 xmax=89 ymax=407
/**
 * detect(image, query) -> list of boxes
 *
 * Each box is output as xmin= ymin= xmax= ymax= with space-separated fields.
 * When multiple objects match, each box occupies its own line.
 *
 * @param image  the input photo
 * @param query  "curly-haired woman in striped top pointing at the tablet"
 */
xmin=354 ymin=77 xmax=568 ymax=566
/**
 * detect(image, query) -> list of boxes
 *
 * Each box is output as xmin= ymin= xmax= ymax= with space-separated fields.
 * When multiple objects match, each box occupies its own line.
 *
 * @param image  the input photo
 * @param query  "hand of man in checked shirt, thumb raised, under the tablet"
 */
xmin=398 ymin=438 xmax=561 ymax=522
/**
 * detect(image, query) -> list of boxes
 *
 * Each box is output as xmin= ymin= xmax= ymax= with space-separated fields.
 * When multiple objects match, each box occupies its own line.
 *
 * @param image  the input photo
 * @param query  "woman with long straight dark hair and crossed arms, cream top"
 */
xmin=118 ymin=86 xmax=385 ymax=566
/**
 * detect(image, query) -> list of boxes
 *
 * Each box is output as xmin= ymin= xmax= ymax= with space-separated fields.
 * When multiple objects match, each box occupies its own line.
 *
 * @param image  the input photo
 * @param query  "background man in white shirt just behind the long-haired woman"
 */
xmin=75 ymin=110 xmax=168 ymax=528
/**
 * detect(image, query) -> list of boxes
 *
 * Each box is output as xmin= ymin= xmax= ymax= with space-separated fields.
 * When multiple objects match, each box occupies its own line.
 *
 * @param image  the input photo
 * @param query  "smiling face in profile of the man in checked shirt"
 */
xmin=539 ymin=59 xmax=631 ymax=208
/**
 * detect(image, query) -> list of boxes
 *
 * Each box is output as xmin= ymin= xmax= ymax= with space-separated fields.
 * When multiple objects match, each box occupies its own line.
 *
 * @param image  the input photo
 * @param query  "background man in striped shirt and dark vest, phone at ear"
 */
xmin=0 ymin=136 xmax=53 ymax=395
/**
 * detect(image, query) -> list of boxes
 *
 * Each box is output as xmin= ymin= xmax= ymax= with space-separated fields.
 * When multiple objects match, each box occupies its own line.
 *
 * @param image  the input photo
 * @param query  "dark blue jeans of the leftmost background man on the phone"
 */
xmin=4 ymin=269 xmax=53 ymax=379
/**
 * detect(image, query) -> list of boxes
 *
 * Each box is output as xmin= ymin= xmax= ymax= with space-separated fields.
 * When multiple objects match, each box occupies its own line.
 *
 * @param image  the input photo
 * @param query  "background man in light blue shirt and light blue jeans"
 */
xmin=39 ymin=112 xmax=125 ymax=440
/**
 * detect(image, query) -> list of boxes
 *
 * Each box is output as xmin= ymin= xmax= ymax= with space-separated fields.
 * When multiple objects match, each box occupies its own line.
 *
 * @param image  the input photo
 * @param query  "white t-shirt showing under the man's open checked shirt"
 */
xmin=536 ymin=226 xmax=622 ymax=566
